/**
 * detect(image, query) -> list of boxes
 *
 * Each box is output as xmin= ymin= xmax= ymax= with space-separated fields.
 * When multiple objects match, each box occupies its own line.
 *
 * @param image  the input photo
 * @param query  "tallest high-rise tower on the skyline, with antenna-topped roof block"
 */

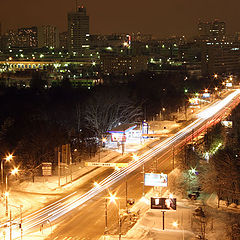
xmin=68 ymin=6 xmax=90 ymax=54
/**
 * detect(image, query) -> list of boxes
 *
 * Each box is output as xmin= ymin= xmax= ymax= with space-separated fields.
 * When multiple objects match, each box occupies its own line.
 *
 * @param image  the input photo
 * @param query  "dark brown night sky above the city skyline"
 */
xmin=0 ymin=0 xmax=240 ymax=37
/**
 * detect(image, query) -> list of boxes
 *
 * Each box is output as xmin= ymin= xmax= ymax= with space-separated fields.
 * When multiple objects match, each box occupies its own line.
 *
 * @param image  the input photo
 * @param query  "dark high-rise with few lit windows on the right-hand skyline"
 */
xmin=198 ymin=20 xmax=226 ymax=41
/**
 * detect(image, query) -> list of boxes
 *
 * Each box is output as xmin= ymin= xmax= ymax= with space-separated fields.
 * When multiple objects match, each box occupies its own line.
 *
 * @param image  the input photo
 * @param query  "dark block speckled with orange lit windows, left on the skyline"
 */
xmin=17 ymin=27 xmax=38 ymax=48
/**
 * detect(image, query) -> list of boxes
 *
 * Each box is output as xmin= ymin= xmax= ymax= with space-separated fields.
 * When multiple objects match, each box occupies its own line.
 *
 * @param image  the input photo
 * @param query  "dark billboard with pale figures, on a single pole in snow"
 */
xmin=151 ymin=197 xmax=177 ymax=210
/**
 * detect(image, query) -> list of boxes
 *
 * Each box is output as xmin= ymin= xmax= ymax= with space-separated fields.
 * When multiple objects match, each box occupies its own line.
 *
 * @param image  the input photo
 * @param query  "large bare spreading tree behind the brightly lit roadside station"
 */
xmin=85 ymin=87 xmax=142 ymax=137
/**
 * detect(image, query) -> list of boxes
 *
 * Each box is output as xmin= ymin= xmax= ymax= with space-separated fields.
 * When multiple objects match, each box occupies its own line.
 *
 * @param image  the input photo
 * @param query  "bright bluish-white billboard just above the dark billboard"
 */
xmin=144 ymin=173 xmax=168 ymax=187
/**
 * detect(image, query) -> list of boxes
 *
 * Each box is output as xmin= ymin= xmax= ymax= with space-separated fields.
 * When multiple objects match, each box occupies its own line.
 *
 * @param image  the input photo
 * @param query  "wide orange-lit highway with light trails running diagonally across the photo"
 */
xmin=0 ymin=90 xmax=240 ymax=239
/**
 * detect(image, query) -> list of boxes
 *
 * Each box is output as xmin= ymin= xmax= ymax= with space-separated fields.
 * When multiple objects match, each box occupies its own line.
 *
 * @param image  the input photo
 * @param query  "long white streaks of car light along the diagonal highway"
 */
xmin=0 ymin=90 xmax=240 ymax=239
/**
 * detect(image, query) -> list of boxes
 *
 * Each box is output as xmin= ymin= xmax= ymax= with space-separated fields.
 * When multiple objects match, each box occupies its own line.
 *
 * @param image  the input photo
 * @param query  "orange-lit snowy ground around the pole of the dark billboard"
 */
xmin=99 ymin=169 xmax=195 ymax=240
